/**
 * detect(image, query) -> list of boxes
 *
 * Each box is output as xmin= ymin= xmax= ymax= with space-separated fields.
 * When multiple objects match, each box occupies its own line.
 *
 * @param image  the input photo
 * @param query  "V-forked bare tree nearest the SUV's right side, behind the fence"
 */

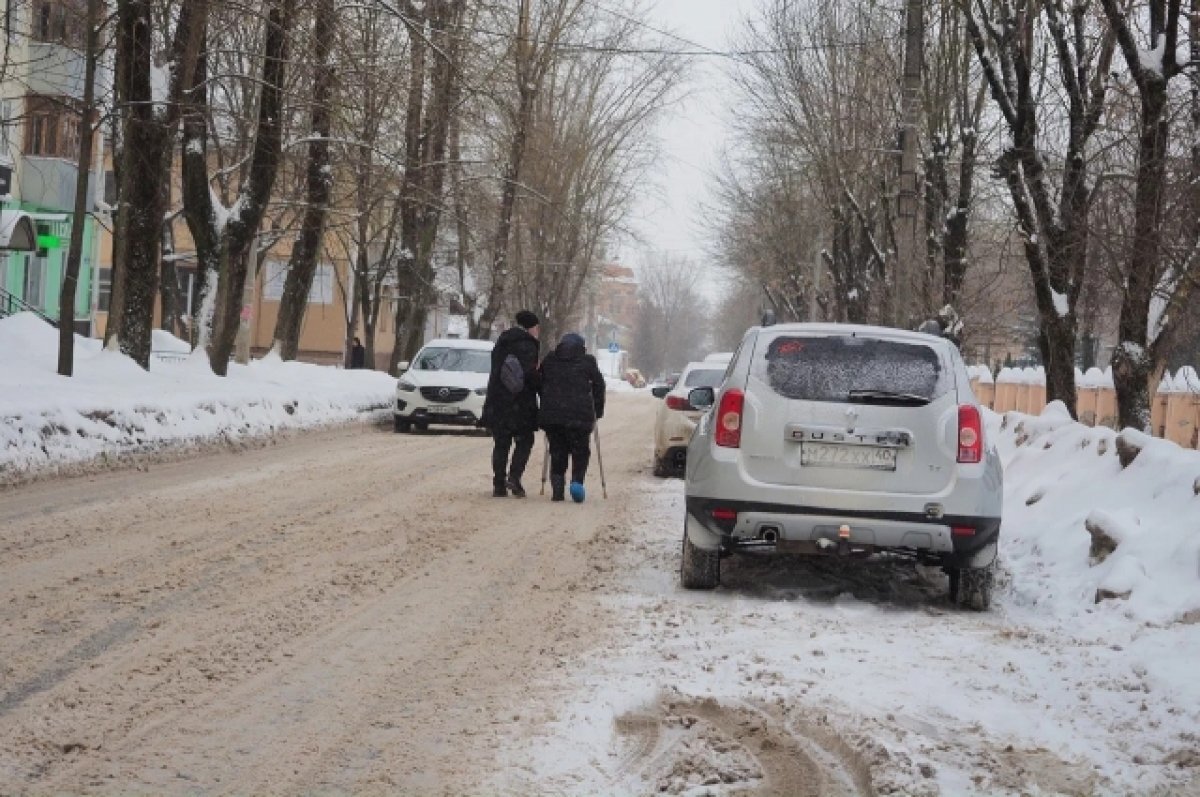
xmin=960 ymin=0 xmax=1115 ymax=415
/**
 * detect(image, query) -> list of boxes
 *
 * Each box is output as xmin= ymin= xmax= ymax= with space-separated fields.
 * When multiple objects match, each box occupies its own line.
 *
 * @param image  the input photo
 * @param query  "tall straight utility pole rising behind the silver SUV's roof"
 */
xmin=893 ymin=0 xmax=925 ymax=329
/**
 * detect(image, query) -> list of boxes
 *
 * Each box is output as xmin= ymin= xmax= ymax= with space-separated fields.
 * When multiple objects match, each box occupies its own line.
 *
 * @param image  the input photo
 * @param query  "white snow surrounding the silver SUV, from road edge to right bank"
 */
xmin=497 ymin=405 xmax=1200 ymax=795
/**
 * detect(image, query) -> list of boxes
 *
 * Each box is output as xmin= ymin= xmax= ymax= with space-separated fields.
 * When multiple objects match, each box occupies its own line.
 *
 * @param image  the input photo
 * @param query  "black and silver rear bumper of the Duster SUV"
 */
xmin=686 ymin=496 xmax=1001 ymax=564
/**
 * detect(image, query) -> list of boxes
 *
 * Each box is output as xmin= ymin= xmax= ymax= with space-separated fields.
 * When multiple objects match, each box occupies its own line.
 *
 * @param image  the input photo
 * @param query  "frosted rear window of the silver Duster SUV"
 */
xmin=754 ymin=335 xmax=950 ymax=402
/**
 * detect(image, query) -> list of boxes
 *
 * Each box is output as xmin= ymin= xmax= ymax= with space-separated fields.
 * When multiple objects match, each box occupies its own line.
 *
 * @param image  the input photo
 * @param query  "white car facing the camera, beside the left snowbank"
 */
xmin=392 ymin=338 xmax=494 ymax=432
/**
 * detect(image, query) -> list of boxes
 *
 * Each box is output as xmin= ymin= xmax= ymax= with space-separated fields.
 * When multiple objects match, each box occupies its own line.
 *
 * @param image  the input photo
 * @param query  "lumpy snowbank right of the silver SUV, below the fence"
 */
xmin=988 ymin=402 xmax=1200 ymax=624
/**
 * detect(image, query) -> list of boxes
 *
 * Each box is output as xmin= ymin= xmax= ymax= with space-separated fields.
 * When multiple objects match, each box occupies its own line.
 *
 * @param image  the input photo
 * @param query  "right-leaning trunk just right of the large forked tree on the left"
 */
xmin=268 ymin=0 xmax=337 ymax=360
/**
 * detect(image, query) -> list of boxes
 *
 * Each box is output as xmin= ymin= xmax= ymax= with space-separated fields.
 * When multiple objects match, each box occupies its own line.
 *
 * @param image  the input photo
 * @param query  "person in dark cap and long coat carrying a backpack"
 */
xmin=480 ymin=310 xmax=540 ymax=498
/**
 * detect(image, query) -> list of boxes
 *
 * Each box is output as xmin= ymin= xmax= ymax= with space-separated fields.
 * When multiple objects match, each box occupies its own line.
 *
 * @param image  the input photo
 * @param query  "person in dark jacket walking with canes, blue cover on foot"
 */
xmin=538 ymin=332 xmax=605 ymax=502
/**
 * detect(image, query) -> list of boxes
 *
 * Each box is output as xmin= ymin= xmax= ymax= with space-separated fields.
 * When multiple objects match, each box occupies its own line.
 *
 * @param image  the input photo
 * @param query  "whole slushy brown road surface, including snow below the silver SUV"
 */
xmin=0 ymin=394 xmax=1200 ymax=795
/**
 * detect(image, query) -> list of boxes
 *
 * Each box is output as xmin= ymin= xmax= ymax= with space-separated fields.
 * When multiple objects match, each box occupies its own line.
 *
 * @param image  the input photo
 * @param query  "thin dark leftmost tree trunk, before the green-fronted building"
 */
xmin=59 ymin=0 xmax=101 ymax=377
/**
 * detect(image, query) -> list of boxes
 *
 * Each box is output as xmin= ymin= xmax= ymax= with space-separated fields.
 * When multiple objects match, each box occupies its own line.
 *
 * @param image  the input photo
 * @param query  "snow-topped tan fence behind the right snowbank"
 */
xmin=970 ymin=365 xmax=1200 ymax=449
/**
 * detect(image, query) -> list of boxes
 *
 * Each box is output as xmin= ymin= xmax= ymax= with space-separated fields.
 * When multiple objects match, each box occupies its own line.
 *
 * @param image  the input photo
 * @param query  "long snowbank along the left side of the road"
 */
xmin=0 ymin=313 xmax=395 ymax=483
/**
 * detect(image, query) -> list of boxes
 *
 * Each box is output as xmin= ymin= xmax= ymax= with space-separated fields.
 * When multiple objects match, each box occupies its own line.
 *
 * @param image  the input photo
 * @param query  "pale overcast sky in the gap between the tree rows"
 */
xmin=616 ymin=0 xmax=755 ymax=293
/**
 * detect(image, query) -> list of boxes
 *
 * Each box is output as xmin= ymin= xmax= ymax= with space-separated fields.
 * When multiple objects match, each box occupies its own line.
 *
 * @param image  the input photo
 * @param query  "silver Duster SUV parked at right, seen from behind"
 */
xmin=680 ymin=324 xmax=1003 ymax=610
